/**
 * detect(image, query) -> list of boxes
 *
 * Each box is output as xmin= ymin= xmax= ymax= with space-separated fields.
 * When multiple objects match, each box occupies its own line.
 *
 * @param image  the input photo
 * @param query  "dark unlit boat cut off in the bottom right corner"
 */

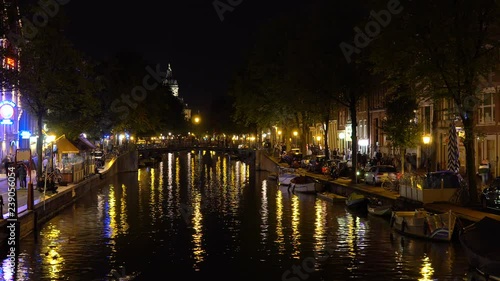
xmin=458 ymin=214 xmax=500 ymax=280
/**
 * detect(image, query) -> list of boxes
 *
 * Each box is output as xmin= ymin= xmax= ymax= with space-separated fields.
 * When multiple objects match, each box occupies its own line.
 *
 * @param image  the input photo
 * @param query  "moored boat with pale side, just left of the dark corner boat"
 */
xmin=391 ymin=209 xmax=457 ymax=241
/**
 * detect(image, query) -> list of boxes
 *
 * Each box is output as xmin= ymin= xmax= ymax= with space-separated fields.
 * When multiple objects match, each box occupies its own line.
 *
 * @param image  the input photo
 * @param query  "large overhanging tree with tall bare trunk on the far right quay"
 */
xmin=372 ymin=0 xmax=500 ymax=203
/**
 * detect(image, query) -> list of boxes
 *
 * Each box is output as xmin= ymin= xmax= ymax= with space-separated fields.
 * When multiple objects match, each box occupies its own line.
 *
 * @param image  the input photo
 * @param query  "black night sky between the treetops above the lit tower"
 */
xmin=63 ymin=0 xmax=292 ymax=114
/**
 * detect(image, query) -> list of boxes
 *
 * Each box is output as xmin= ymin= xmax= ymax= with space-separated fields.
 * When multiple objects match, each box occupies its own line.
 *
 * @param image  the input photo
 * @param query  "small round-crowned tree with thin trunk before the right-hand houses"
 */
xmin=381 ymin=85 xmax=421 ymax=174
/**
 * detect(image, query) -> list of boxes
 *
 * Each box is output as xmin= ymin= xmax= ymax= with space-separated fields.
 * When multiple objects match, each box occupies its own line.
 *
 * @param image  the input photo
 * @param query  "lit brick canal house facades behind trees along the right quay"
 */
xmin=306 ymin=76 xmax=500 ymax=177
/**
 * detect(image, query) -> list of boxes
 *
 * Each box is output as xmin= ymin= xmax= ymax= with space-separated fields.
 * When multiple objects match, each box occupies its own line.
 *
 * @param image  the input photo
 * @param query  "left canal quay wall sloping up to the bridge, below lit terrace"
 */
xmin=0 ymin=151 xmax=139 ymax=246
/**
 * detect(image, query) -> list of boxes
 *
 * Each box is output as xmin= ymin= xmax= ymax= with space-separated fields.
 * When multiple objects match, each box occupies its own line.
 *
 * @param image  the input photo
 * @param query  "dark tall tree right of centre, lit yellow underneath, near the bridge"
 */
xmin=229 ymin=11 xmax=301 ymax=147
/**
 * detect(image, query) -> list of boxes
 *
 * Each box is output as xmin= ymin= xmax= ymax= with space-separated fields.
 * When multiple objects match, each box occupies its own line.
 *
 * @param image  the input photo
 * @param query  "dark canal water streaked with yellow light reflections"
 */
xmin=0 ymin=152 xmax=476 ymax=281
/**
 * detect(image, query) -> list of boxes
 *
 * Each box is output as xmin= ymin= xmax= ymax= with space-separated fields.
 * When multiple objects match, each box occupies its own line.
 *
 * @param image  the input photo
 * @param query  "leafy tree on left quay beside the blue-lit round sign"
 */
xmin=16 ymin=6 xmax=95 ymax=177
